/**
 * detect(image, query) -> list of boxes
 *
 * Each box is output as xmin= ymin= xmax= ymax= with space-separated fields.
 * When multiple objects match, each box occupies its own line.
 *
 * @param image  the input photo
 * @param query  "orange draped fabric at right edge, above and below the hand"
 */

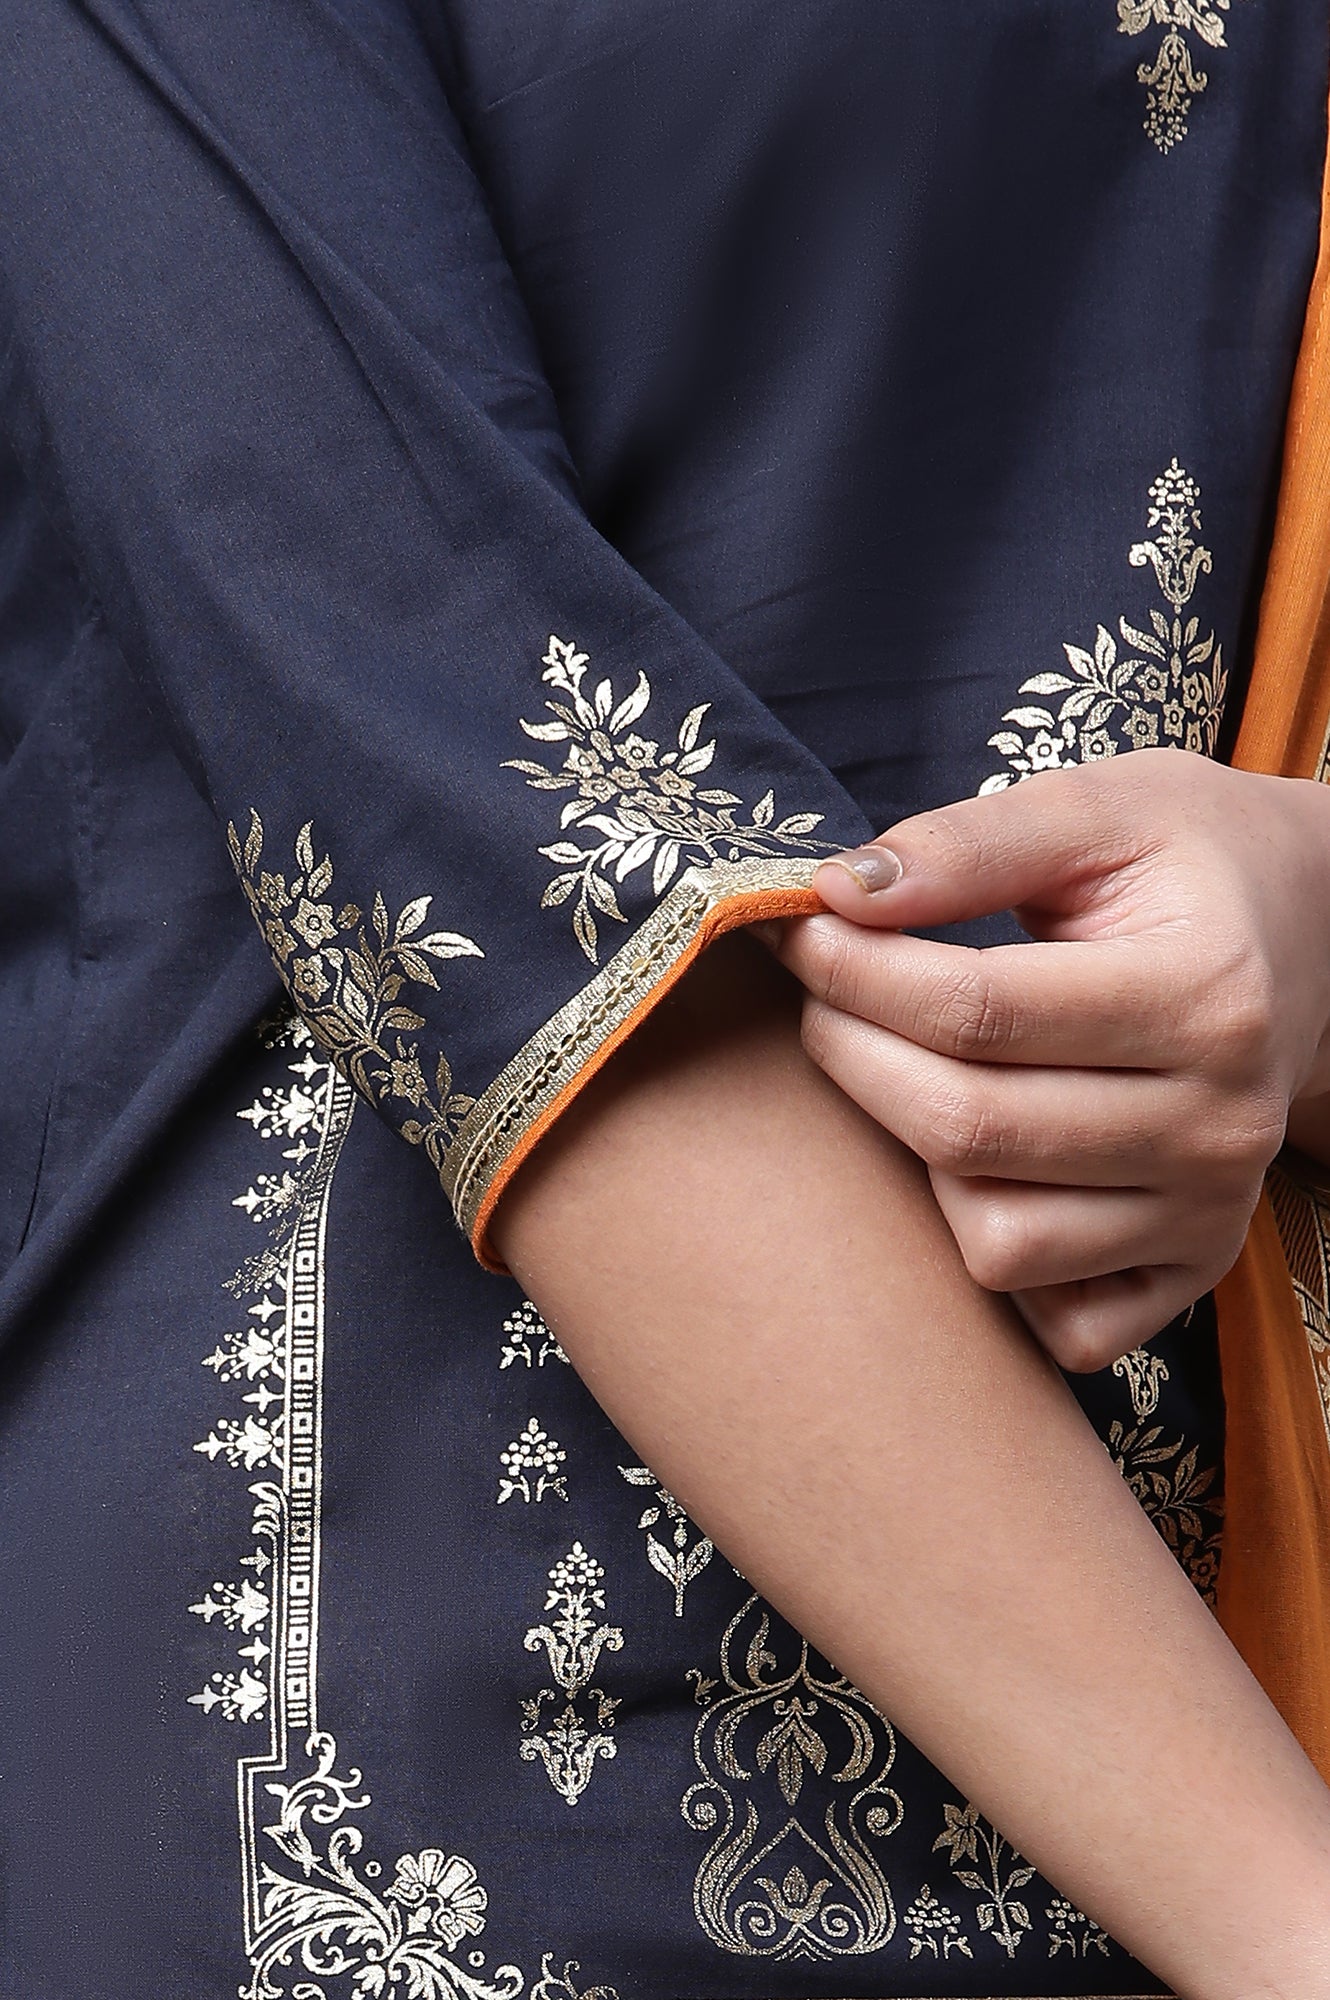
xmin=1216 ymin=94 xmax=1330 ymax=1780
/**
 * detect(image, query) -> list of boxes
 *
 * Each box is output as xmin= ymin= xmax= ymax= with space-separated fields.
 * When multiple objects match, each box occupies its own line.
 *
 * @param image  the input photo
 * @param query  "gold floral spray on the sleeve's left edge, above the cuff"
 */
xmin=226 ymin=810 xmax=484 ymax=1170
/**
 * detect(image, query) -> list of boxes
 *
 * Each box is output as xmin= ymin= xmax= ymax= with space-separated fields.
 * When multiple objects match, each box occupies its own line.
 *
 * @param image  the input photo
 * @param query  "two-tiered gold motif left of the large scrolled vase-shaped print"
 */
xmin=522 ymin=1542 xmax=624 ymax=1806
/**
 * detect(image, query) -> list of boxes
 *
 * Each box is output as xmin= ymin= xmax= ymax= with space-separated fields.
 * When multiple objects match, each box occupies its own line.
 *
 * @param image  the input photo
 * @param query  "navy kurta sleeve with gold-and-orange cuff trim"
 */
xmin=0 ymin=0 xmax=866 ymax=1260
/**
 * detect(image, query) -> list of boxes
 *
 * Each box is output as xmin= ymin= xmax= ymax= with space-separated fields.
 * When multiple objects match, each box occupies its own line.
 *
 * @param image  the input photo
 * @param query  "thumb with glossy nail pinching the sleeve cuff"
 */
xmin=814 ymin=766 xmax=1144 ymax=930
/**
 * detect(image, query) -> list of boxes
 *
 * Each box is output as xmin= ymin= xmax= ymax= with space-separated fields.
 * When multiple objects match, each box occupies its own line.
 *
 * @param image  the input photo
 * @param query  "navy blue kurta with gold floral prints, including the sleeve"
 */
xmin=0 ymin=0 xmax=1330 ymax=2000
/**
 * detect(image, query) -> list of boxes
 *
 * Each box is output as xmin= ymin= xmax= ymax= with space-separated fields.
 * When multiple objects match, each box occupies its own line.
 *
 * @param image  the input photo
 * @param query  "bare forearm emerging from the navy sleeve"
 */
xmin=494 ymin=940 xmax=1330 ymax=2000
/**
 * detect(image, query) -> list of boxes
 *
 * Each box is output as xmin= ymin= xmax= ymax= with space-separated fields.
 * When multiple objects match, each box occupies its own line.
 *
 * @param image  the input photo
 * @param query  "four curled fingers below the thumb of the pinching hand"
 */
xmin=804 ymin=992 xmax=1278 ymax=1372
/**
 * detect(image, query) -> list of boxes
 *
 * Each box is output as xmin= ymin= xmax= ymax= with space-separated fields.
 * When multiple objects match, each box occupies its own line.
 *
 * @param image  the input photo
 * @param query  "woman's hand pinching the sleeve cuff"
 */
xmin=778 ymin=750 xmax=1330 ymax=1370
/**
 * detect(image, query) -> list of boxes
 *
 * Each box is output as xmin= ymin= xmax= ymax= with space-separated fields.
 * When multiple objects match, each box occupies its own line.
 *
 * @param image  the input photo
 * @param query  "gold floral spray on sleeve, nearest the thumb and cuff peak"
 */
xmin=504 ymin=634 xmax=830 ymax=964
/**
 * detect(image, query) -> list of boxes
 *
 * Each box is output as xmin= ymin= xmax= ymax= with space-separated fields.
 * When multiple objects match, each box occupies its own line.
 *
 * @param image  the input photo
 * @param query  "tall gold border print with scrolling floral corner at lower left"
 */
xmin=188 ymin=1020 xmax=618 ymax=2000
